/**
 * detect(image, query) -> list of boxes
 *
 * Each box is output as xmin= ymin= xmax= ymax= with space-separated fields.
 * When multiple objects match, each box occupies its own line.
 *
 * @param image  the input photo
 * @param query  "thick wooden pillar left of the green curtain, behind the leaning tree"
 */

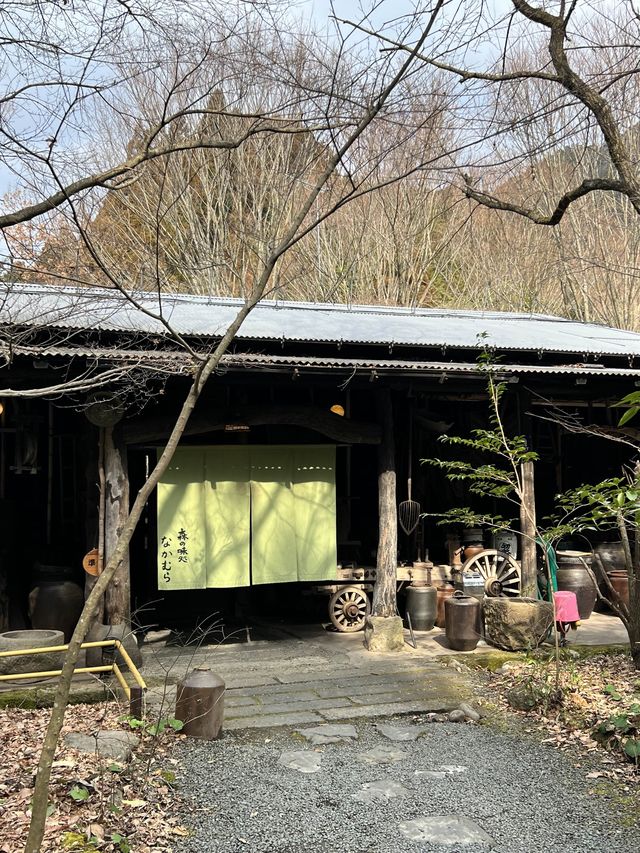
xmin=104 ymin=427 xmax=131 ymax=625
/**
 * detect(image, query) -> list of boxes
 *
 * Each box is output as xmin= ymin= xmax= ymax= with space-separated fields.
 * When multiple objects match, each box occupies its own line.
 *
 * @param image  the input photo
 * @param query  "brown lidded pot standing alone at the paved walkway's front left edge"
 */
xmin=176 ymin=666 xmax=225 ymax=740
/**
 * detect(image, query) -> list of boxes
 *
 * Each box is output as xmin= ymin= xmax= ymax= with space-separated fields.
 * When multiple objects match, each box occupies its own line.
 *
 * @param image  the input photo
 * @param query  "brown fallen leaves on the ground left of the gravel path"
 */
xmin=0 ymin=702 xmax=189 ymax=853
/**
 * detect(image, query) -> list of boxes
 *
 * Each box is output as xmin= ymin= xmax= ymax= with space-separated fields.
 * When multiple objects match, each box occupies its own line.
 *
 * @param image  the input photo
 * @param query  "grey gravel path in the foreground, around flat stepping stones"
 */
xmin=176 ymin=718 xmax=639 ymax=853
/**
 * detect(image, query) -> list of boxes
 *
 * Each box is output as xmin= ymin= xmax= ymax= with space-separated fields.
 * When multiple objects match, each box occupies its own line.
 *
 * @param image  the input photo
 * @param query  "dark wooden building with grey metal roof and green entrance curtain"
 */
xmin=0 ymin=284 xmax=640 ymax=630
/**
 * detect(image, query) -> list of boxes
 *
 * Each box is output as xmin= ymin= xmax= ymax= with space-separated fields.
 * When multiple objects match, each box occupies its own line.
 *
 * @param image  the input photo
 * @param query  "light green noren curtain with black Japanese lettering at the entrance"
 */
xmin=158 ymin=445 xmax=336 ymax=589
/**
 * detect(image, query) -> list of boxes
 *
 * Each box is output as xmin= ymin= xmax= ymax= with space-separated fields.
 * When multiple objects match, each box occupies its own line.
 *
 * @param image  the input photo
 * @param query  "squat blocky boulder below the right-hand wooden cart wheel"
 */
xmin=484 ymin=597 xmax=554 ymax=652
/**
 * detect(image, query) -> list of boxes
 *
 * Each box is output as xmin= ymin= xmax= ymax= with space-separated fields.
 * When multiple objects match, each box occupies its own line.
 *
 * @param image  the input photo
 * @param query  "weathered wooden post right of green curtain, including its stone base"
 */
xmin=364 ymin=388 xmax=404 ymax=651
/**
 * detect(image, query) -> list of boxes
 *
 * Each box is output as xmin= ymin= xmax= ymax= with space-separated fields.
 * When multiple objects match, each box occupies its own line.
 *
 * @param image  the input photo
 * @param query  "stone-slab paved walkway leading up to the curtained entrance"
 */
xmin=144 ymin=628 xmax=478 ymax=730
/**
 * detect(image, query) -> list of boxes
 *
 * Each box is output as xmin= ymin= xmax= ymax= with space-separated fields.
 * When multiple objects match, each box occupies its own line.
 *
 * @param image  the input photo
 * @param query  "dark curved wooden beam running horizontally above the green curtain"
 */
xmin=118 ymin=405 xmax=381 ymax=444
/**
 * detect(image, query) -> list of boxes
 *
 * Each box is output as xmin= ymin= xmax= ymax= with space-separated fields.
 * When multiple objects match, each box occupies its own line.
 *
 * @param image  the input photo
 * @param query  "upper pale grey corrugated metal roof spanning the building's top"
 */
xmin=0 ymin=284 xmax=640 ymax=356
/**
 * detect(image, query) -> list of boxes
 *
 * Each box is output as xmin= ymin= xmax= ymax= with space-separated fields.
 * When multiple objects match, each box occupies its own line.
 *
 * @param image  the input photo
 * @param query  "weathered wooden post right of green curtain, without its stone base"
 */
xmin=373 ymin=388 xmax=398 ymax=616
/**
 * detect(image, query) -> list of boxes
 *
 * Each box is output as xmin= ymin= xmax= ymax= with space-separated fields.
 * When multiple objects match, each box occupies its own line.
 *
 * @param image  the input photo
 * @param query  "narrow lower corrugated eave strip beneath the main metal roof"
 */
xmin=14 ymin=345 xmax=640 ymax=380
